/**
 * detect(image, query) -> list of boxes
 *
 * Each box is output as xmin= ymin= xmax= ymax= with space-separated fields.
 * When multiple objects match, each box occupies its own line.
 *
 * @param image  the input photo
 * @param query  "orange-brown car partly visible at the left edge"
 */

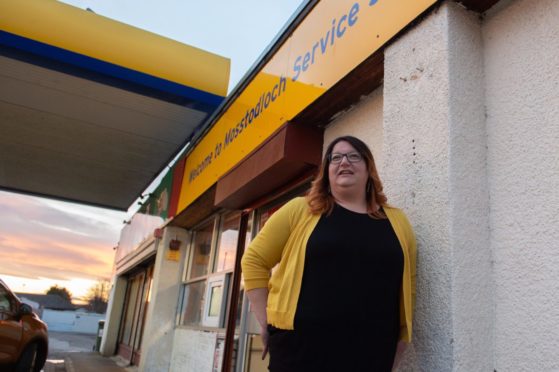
xmin=0 ymin=279 xmax=48 ymax=372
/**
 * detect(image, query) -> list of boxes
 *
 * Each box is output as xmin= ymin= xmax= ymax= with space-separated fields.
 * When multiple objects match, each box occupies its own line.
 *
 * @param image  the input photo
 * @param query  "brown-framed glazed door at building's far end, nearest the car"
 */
xmin=117 ymin=263 xmax=153 ymax=365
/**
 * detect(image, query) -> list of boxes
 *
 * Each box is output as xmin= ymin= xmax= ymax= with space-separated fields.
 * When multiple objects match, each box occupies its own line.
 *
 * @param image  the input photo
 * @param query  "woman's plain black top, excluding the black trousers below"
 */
xmin=295 ymin=205 xmax=404 ymax=329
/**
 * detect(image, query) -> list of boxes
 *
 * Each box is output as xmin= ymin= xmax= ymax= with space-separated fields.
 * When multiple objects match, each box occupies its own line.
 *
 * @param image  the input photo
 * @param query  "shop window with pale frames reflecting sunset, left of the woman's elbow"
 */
xmin=179 ymin=212 xmax=240 ymax=328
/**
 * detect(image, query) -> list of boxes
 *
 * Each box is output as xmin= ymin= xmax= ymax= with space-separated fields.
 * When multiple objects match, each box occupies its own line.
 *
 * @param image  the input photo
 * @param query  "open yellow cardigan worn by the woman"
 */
xmin=242 ymin=197 xmax=416 ymax=342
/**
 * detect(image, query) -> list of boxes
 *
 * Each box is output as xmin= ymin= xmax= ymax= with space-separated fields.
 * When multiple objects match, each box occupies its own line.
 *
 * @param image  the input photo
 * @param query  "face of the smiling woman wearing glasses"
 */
xmin=328 ymin=141 xmax=369 ymax=192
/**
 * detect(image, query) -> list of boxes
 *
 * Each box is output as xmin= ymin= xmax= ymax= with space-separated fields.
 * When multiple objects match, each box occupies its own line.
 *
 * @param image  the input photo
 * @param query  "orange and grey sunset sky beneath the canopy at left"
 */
xmin=0 ymin=191 xmax=126 ymax=297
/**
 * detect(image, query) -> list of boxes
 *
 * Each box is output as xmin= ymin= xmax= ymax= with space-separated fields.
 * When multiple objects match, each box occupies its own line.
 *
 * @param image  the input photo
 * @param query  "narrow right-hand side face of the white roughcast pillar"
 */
xmin=445 ymin=2 xmax=495 ymax=371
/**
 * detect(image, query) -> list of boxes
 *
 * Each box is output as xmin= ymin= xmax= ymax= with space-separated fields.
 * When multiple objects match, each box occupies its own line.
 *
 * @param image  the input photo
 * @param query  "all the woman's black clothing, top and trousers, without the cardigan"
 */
xmin=270 ymin=205 xmax=404 ymax=371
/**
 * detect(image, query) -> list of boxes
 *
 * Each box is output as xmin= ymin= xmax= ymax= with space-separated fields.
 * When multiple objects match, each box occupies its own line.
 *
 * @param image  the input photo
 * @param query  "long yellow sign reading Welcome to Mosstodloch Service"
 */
xmin=178 ymin=0 xmax=436 ymax=211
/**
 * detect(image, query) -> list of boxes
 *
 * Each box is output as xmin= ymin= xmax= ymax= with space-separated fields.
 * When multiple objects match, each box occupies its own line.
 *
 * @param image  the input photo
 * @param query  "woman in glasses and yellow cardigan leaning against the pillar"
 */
xmin=242 ymin=136 xmax=416 ymax=372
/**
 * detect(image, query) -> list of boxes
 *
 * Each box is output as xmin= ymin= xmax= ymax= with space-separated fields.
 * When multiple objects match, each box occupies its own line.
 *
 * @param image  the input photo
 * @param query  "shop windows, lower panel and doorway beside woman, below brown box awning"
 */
xmin=172 ymin=181 xmax=309 ymax=372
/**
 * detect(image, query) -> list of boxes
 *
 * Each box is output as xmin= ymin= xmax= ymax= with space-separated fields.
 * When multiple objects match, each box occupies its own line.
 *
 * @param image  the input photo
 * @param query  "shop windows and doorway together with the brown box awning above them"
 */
xmin=170 ymin=120 xmax=322 ymax=371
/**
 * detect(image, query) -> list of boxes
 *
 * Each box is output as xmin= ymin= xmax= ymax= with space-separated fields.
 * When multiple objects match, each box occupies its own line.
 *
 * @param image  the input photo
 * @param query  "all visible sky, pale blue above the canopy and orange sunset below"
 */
xmin=0 ymin=0 xmax=303 ymax=297
